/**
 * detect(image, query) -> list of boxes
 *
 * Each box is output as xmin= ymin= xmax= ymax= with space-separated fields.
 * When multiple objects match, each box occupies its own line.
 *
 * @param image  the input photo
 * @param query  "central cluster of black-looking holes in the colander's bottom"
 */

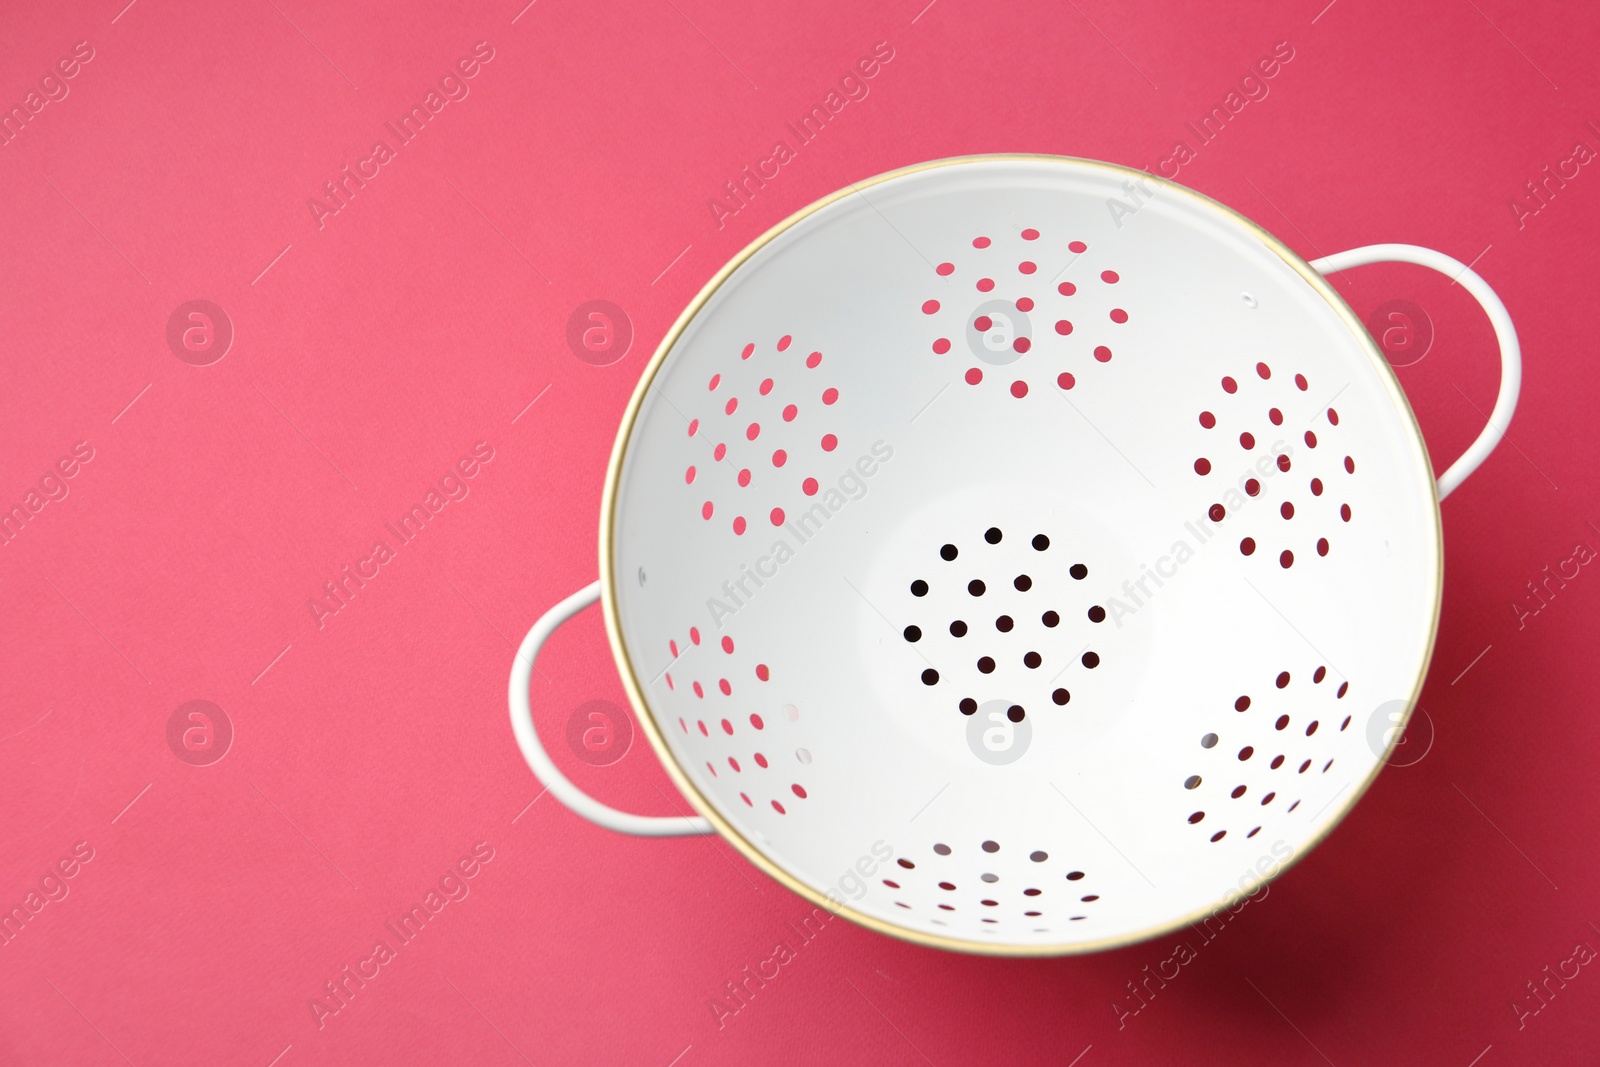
xmin=901 ymin=526 xmax=1106 ymax=723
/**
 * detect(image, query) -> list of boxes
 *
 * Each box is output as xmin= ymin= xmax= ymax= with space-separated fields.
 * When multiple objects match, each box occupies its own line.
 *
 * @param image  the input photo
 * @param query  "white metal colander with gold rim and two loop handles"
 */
xmin=510 ymin=157 xmax=1520 ymax=955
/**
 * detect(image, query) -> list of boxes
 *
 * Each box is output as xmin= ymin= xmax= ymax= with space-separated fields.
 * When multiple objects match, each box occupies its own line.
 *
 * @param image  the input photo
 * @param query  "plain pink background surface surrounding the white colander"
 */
xmin=0 ymin=0 xmax=1600 ymax=1067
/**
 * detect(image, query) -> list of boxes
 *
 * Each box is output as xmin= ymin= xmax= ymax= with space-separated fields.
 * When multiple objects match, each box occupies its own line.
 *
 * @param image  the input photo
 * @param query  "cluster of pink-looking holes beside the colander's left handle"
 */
xmin=662 ymin=627 xmax=813 ymax=816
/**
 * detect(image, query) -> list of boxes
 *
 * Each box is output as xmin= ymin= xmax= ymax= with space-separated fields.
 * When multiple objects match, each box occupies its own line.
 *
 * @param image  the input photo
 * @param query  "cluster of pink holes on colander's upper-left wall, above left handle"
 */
xmin=683 ymin=334 xmax=838 ymax=536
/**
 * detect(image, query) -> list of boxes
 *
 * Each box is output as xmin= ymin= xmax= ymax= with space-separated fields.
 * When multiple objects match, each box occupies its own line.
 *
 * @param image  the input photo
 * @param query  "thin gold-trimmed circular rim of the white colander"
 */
xmin=598 ymin=152 xmax=1445 ymax=958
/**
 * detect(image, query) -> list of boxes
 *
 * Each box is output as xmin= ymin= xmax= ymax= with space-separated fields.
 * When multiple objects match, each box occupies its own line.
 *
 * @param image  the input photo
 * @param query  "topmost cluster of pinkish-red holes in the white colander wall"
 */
xmin=922 ymin=227 xmax=1128 ymax=400
